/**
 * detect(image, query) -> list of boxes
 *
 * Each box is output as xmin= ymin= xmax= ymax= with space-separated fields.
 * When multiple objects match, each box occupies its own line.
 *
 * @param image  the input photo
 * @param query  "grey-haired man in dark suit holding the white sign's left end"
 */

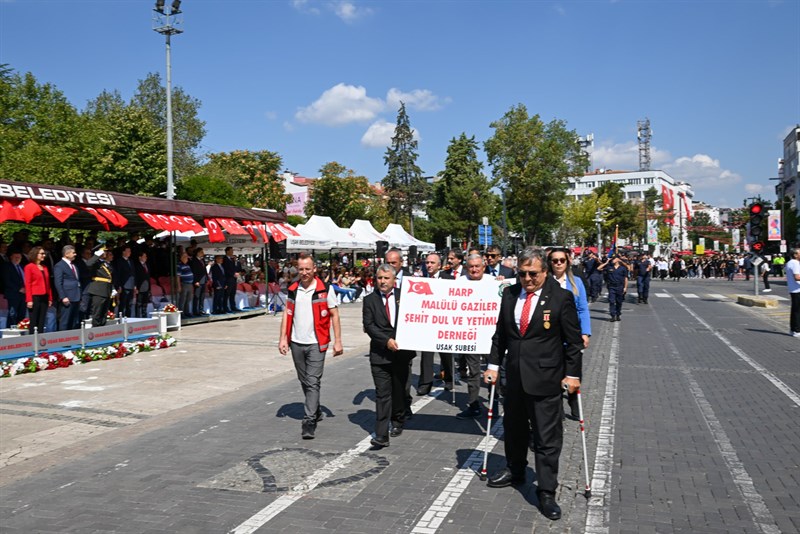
xmin=363 ymin=263 xmax=414 ymax=448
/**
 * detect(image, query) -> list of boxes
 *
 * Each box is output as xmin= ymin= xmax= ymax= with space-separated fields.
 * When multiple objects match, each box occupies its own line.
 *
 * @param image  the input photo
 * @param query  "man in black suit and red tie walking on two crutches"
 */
xmin=484 ymin=248 xmax=583 ymax=520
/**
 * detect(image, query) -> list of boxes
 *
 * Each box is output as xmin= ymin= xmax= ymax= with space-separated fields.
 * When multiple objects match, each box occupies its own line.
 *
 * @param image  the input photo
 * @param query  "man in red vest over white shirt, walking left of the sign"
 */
xmin=278 ymin=255 xmax=344 ymax=439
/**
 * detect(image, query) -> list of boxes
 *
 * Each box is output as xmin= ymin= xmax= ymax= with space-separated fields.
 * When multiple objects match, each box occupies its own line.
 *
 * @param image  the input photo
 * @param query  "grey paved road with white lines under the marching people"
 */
xmin=0 ymin=280 xmax=800 ymax=534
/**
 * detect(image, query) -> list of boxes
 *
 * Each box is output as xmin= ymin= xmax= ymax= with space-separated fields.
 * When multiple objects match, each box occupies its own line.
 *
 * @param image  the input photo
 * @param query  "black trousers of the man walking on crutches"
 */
xmin=503 ymin=376 xmax=564 ymax=492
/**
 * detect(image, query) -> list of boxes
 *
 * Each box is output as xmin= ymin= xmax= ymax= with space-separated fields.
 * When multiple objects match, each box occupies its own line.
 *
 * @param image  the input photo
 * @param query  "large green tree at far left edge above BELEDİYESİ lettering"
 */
xmin=0 ymin=69 xmax=84 ymax=185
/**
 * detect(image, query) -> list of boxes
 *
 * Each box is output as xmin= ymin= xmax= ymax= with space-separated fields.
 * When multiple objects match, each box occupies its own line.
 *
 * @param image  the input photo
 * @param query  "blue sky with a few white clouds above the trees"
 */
xmin=0 ymin=0 xmax=800 ymax=207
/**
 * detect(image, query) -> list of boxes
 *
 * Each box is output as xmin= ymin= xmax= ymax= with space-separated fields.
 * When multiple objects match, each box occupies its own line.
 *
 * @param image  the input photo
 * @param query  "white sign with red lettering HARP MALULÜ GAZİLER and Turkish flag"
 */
xmin=397 ymin=276 xmax=509 ymax=354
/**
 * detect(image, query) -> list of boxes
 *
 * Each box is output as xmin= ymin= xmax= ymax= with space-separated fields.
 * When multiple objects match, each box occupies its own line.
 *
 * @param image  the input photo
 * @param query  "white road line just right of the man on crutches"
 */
xmin=583 ymin=323 xmax=619 ymax=534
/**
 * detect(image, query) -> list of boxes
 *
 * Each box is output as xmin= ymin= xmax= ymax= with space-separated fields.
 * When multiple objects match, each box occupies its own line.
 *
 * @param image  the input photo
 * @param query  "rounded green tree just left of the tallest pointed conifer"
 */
xmin=306 ymin=161 xmax=376 ymax=228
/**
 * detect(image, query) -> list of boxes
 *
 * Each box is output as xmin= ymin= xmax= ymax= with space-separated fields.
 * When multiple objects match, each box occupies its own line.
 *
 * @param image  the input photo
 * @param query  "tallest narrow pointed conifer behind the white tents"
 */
xmin=381 ymin=102 xmax=428 ymax=235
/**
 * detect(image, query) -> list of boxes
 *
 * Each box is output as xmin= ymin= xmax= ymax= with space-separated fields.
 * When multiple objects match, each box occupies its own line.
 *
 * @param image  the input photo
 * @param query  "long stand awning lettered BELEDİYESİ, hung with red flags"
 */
xmin=0 ymin=180 xmax=286 ymax=235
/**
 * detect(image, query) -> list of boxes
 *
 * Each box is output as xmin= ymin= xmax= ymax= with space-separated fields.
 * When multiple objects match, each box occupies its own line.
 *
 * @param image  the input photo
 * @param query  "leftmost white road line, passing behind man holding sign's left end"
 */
xmin=230 ymin=388 xmax=444 ymax=534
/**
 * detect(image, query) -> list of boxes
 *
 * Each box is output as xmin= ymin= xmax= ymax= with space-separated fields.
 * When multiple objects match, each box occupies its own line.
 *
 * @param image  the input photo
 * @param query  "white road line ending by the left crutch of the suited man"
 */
xmin=411 ymin=416 xmax=503 ymax=534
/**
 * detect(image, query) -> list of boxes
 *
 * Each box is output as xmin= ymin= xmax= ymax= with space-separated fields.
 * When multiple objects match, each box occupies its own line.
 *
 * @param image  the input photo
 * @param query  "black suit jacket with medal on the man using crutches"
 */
xmin=489 ymin=276 xmax=583 ymax=395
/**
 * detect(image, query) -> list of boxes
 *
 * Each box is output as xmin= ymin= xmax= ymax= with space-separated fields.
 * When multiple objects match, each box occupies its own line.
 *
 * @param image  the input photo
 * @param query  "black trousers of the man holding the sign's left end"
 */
xmin=370 ymin=351 xmax=413 ymax=441
